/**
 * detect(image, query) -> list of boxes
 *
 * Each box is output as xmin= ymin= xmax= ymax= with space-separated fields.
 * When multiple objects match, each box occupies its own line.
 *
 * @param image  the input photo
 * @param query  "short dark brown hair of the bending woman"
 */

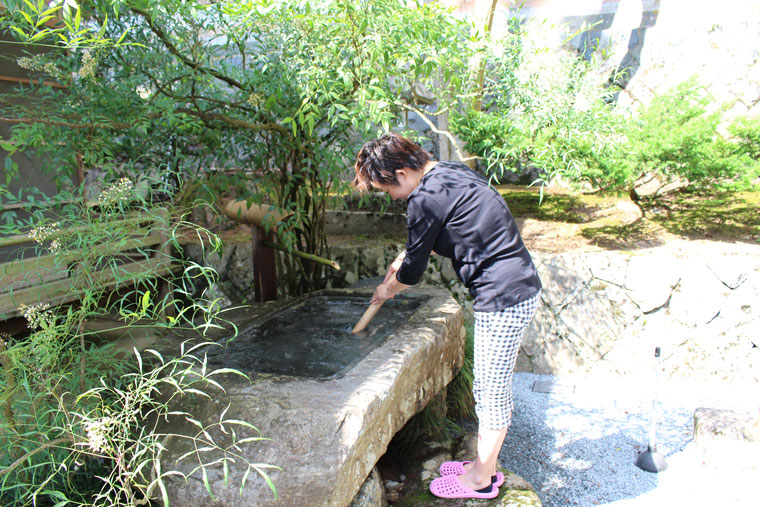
xmin=353 ymin=134 xmax=431 ymax=191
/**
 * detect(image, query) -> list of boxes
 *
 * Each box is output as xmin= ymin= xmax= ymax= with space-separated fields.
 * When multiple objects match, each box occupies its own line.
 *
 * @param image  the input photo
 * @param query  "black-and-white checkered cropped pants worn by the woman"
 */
xmin=472 ymin=292 xmax=541 ymax=430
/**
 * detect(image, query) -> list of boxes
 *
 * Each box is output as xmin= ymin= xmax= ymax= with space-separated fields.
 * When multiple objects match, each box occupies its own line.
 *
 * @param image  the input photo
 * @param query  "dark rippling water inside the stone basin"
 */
xmin=208 ymin=294 xmax=423 ymax=379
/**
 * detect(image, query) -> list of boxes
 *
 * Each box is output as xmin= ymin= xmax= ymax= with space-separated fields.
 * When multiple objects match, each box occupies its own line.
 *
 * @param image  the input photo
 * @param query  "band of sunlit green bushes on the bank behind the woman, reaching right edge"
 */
xmin=453 ymin=17 xmax=760 ymax=198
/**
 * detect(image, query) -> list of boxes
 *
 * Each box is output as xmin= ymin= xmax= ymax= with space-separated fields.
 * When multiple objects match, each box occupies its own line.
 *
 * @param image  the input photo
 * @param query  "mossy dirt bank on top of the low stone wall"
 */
xmin=212 ymin=186 xmax=760 ymax=253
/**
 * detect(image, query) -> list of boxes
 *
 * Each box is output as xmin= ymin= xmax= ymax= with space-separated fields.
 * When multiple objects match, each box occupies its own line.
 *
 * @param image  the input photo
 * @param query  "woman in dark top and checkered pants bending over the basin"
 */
xmin=354 ymin=134 xmax=541 ymax=498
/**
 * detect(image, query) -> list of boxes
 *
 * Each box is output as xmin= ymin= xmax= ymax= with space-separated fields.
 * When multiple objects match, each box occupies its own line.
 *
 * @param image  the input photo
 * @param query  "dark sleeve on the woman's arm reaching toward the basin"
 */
xmin=396 ymin=196 xmax=443 ymax=285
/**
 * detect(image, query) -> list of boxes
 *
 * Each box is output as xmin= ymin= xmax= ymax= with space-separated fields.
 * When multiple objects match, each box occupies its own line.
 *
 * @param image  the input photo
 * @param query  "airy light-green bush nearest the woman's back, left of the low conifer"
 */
xmin=453 ymin=17 xmax=620 ymax=190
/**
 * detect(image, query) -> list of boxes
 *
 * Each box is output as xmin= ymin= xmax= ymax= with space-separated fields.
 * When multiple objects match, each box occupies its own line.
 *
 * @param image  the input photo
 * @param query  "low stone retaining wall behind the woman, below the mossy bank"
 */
xmin=190 ymin=236 xmax=760 ymax=382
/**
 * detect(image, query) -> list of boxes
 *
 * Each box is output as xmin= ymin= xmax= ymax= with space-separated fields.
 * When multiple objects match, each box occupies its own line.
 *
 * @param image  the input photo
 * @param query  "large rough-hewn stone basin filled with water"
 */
xmin=162 ymin=288 xmax=465 ymax=507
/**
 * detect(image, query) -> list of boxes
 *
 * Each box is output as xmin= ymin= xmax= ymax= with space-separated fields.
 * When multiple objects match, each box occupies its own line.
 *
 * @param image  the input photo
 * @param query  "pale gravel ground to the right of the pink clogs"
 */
xmin=500 ymin=373 xmax=760 ymax=507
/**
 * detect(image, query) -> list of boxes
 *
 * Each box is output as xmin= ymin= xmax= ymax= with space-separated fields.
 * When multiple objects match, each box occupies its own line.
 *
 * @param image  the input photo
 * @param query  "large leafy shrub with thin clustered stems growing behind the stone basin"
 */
xmin=0 ymin=0 xmax=470 ymax=293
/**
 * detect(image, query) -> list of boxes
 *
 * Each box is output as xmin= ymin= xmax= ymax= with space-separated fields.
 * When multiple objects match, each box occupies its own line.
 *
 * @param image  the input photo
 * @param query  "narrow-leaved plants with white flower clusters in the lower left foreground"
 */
xmin=0 ymin=180 xmax=274 ymax=505
